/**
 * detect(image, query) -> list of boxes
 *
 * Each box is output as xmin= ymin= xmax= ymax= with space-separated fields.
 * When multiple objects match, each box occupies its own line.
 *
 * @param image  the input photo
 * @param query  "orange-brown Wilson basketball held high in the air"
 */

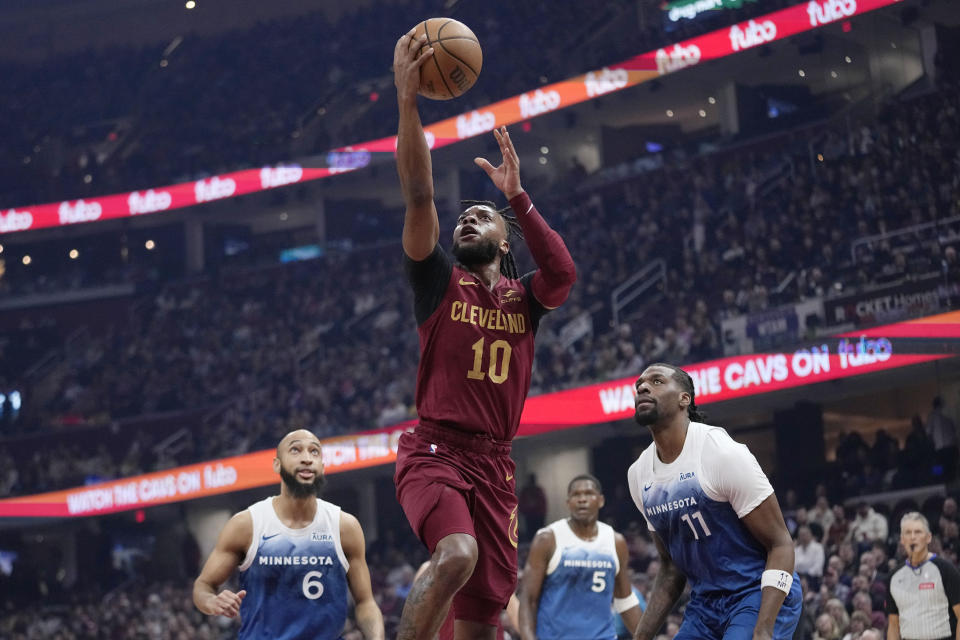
xmin=414 ymin=18 xmax=483 ymax=100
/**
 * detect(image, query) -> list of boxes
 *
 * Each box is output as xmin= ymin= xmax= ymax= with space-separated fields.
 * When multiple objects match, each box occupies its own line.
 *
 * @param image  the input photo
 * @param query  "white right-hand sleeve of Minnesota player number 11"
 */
xmin=700 ymin=427 xmax=773 ymax=518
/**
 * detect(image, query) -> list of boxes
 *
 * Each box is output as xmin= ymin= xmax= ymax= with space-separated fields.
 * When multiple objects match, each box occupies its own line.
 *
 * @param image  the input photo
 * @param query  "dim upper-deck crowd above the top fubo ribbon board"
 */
xmin=0 ymin=0 xmax=808 ymax=208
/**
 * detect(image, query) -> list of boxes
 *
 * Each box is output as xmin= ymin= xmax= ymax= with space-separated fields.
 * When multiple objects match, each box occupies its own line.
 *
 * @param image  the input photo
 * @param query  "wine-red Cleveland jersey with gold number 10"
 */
xmin=407 ymin=245 xmax=546 ymax=440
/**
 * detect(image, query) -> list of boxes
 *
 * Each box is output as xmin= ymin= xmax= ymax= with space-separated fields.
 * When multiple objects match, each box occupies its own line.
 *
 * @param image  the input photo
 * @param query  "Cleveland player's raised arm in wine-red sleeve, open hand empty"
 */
xmin=474 ymin=127 xmax=577 ymax=309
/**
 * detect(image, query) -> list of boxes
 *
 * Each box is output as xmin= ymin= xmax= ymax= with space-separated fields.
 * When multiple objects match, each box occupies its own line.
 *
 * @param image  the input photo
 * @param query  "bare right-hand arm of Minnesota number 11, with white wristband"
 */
xmin=741 ymin=494 xmax=795 ymax=640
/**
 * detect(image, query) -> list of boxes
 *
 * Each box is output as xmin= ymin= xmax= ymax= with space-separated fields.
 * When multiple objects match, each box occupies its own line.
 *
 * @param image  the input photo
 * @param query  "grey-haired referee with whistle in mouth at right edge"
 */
xmin=887 ymin=511 xmax=960 ymax=640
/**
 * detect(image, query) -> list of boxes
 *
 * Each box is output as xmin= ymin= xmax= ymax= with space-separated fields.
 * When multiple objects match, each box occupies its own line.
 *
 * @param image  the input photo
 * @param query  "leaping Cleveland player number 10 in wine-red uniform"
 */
xmin=393 ymin=31 xmax=576 ymax=640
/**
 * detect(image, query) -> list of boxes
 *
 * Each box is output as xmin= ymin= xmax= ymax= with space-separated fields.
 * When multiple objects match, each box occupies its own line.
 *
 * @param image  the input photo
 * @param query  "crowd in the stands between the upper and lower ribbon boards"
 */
xmin=0 ymin=74 xmax=960 ymax=493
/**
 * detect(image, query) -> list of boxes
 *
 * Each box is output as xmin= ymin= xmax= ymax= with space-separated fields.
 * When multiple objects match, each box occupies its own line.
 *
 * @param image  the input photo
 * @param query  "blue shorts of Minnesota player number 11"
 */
xmin=674 ymin=576 xmax=803 ymax=640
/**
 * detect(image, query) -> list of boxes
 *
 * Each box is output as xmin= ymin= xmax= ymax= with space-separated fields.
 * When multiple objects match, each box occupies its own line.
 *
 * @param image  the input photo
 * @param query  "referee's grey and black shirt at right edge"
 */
xmin=887 ymin=554 xmax=960 ymax=640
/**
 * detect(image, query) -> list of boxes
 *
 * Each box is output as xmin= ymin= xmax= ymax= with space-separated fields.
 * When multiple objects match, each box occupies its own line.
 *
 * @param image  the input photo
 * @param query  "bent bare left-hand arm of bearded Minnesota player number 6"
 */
xmin=193 ymin=510 xmax=253 ymax=618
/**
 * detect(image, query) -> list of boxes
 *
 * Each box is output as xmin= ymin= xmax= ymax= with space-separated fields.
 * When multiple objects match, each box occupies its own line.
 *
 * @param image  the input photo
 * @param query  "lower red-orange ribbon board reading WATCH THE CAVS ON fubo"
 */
xmin=0 ymin=311 xmax=960 ymax=518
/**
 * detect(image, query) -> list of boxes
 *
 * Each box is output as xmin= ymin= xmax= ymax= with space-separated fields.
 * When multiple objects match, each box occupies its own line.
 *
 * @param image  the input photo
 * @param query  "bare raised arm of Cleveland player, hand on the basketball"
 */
xmin=393 ymin=30 xmax=440 ymax=260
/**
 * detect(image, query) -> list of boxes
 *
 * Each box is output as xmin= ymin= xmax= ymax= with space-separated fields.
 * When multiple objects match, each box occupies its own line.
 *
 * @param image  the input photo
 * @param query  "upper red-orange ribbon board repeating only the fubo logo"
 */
xmin=0 ymin=0 xmax=904 ymax=233
